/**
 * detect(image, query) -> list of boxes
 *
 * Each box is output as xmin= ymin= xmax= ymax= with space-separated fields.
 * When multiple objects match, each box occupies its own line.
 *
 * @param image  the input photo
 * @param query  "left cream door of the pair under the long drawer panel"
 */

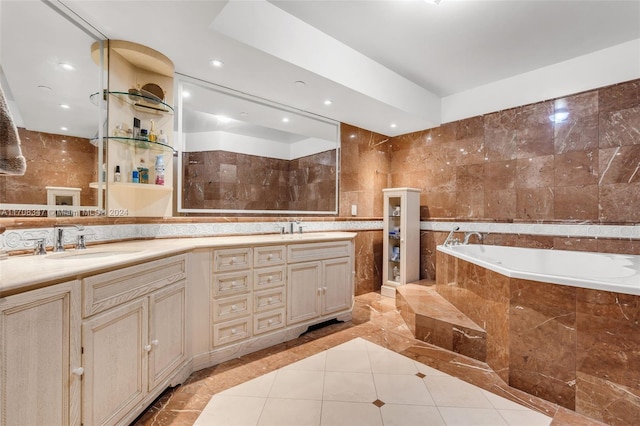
xmin=82 ymin=298 xmax=148 ymax=425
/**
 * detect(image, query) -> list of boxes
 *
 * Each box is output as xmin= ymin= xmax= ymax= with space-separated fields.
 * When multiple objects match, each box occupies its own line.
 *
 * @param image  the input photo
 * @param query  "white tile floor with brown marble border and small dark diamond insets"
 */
xmin=135 ymin=293 xmax=601 ymax=426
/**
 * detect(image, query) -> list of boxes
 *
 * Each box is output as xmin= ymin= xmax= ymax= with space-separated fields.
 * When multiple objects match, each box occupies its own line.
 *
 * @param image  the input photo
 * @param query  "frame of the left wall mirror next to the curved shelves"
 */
xmin=0 ymin=0 xmax=108 ymax=218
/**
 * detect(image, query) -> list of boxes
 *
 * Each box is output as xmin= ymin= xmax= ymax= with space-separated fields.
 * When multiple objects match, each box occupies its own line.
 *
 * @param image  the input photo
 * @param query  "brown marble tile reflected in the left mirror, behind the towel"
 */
xmin=0 ymin=128 xmax=98 ymax=210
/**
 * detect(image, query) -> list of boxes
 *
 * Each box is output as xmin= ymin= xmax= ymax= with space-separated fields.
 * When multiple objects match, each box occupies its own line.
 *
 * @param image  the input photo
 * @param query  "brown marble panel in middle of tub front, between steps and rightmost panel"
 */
xmin=509 ymin=279 xmax=577 ymax=410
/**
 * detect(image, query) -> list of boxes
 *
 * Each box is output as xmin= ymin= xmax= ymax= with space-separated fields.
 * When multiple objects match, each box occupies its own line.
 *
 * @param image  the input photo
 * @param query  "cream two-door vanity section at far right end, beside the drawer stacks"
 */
xmin=287 ymin=241 xmax=353 ymax=324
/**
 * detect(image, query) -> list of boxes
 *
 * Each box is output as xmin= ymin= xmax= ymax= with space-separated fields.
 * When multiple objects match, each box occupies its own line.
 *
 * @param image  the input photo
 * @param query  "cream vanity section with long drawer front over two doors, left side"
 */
xmin=82 ymin=255 xmax=187 ymax=425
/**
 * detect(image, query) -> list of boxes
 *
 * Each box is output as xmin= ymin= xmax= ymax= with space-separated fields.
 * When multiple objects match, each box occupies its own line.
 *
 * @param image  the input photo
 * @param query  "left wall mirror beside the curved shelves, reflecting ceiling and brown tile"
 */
xmin=0 ymin=1 xmax=106 ymax=218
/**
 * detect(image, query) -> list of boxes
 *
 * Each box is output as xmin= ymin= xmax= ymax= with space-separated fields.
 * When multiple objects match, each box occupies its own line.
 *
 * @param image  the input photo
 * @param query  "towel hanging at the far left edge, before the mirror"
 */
xmin=0 ymin=88 xmax=27 ymax=176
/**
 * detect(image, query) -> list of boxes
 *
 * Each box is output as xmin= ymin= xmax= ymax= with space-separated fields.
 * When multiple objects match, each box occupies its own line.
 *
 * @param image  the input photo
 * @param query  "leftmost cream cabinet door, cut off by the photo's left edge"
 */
xmin=0 ymin=281 xmax=82 ymax=425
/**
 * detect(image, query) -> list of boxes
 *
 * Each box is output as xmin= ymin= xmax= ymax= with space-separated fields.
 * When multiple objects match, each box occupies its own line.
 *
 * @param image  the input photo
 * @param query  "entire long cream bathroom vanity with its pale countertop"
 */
xmin=0 ymin=232 xmax=355 ymax=425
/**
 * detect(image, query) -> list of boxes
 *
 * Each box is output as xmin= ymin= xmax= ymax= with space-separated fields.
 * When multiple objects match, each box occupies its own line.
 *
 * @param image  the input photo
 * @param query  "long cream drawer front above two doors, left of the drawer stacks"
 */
xmin=82 ymin=255 xmax=187 ymax=317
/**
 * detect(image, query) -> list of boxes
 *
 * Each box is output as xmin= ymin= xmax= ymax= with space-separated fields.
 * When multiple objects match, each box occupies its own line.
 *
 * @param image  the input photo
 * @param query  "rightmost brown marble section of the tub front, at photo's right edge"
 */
xmin=576 ymin=289 xmax=640 ymax=425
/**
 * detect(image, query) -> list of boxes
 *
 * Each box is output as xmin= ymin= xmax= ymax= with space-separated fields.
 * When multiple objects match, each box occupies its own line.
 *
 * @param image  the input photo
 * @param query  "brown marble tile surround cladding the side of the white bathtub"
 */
xmin=436 ymin=251 xmax=640 ymax=425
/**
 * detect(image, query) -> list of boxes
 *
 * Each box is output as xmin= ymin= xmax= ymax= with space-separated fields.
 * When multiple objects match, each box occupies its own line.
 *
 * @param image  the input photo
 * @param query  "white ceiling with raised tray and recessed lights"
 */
xmin=0 ymin=0 xmax=640 ymax=136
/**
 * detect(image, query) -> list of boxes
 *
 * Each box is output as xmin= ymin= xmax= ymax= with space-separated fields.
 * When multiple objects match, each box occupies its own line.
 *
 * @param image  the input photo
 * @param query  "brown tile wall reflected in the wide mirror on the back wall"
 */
xmin=183 ymin=151 xmax=336 ymax=211
